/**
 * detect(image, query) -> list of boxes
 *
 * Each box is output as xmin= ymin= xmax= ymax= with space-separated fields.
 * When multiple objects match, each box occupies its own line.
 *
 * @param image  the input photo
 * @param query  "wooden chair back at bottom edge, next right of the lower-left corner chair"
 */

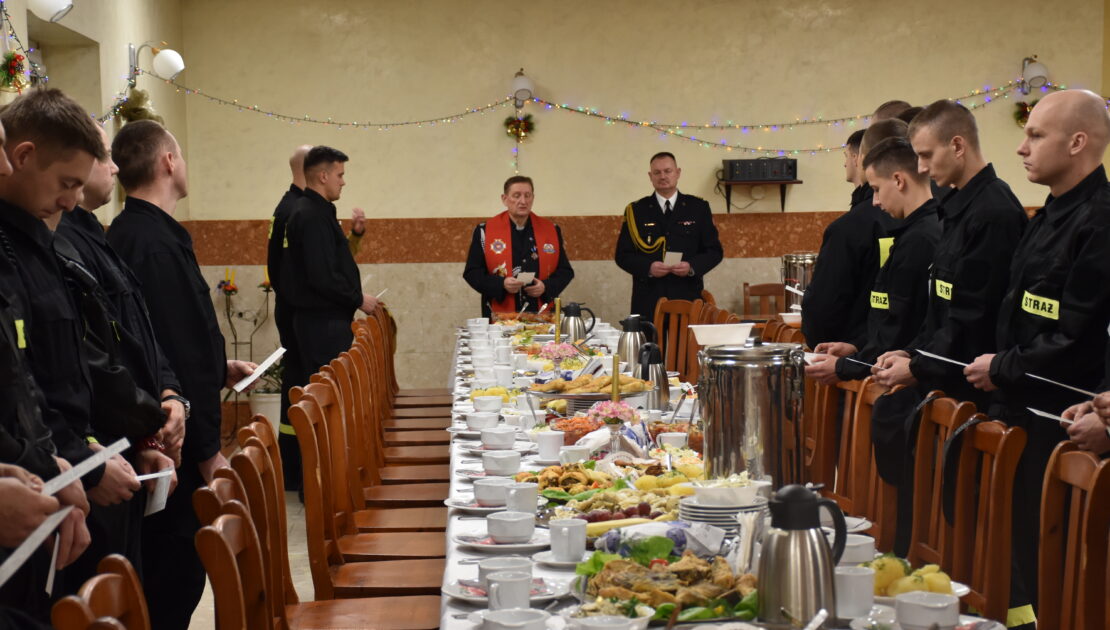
xmin=196 ymin=512 xmax=271 ymax=630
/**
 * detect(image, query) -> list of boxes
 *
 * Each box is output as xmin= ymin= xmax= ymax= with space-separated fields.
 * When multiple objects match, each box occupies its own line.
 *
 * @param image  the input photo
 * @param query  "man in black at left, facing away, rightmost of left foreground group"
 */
xmin=108 ymin=120 xmax=256 ymax=630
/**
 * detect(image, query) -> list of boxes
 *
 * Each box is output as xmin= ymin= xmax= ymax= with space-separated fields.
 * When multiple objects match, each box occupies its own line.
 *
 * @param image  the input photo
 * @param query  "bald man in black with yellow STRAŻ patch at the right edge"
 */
xmin=965 ymin=90 xmax=1110 ymax=623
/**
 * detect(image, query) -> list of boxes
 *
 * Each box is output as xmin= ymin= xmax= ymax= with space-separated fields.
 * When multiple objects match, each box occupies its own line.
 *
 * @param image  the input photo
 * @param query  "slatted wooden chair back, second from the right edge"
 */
xmin=938 ymin=421 xmax=1025 ymax=622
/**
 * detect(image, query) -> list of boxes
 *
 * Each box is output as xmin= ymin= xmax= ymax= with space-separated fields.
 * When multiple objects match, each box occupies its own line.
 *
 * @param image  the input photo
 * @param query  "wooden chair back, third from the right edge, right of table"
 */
xmin=907 ymin=392 xmax=976 ymax=570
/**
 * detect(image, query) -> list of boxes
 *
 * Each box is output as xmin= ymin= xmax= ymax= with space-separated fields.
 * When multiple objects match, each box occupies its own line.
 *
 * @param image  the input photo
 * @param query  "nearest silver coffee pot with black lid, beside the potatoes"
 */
xmin=759 ymin=485 xmax=847 ymax=628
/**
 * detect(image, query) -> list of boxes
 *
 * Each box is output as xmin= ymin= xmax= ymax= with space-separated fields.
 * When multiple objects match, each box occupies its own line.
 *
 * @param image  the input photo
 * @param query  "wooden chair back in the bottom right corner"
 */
xmin=1037 ymin=441 xmax=1110 ymax=630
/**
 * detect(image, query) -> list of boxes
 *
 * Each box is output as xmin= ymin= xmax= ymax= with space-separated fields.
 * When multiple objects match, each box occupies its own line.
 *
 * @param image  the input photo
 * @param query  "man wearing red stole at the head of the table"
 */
xmin=463 ymin=175 xmax=574 ymax=317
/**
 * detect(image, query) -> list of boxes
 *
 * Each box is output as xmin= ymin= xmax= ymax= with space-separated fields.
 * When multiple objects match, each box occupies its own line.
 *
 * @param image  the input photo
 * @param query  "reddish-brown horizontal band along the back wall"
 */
xmin=182 ymin=212 xmax=840 ymax=265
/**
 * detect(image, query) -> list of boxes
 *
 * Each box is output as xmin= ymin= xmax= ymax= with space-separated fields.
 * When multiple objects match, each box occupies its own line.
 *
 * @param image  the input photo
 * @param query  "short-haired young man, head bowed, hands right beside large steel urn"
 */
xmin=806 ymin=138 xmax=940 ymax=384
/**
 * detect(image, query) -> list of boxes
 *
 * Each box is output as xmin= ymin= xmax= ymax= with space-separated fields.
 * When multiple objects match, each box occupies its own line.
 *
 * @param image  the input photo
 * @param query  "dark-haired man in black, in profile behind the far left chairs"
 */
xmin=282 ymin=146 xmax=377 ymax=380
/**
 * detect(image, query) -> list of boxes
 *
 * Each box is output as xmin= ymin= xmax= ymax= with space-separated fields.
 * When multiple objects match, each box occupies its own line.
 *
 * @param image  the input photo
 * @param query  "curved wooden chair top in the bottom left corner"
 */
xmin=50 ymin=553 xmax=150 ymax=630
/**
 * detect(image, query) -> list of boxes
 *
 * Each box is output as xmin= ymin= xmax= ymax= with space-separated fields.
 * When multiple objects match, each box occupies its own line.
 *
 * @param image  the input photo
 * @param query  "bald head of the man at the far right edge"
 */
xmin=1018 ymin=90 xmax=1110 ymax=196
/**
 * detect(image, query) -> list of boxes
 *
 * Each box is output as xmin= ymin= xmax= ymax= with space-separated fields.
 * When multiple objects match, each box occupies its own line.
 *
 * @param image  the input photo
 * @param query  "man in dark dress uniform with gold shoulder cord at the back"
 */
xmin=615 ymin=152 xmax=725 ymax=319
